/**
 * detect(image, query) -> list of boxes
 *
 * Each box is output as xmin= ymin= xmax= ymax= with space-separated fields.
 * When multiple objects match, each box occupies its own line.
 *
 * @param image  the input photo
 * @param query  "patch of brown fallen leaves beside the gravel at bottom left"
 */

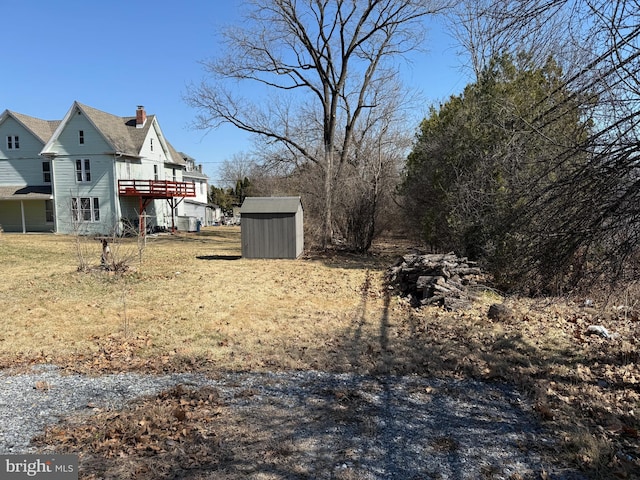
xmin=34 ymin=385 xmax=224 ymax=479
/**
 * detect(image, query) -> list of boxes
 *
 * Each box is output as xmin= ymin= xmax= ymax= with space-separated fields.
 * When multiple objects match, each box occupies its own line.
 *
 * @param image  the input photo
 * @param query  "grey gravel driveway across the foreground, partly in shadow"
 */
xmin=0 ymin=366 xmax=584 ymax=480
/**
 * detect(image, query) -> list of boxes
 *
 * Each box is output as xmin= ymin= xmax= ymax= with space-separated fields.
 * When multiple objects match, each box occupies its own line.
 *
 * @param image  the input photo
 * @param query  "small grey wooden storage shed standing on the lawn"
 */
xmin=240 ymin=197 xmax=304 ymax=259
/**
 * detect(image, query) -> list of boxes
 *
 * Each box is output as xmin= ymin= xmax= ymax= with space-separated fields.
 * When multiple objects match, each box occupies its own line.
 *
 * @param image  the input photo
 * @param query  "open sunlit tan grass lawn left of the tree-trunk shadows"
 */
xmin=0 ymin=227 xmax=384 ymax=370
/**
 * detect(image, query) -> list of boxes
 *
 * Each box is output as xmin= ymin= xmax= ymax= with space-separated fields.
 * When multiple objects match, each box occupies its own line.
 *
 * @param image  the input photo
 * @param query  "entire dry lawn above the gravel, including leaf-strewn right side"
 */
xmin=0 ymin=227 xmax=640 ymax=478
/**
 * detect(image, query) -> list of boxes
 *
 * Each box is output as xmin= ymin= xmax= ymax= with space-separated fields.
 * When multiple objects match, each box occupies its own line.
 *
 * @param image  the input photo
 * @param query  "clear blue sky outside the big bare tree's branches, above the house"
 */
xmin=0 ymin=0 xmax=468 ymax=184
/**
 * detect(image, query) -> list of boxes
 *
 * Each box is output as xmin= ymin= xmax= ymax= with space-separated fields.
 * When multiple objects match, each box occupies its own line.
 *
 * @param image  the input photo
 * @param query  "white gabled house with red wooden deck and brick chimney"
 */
xmin=0 ymin=102 xmax=196 ymax=234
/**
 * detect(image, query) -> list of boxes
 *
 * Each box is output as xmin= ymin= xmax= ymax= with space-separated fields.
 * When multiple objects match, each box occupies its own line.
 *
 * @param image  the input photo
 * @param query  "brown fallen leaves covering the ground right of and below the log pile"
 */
xmin=398 ymin=298 xmax=640 ymax=478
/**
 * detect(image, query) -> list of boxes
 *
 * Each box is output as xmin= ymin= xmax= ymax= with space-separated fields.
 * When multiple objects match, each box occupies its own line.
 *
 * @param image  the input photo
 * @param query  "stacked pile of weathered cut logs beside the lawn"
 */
xmin=387 ymin=253 xmax=484 ymax=310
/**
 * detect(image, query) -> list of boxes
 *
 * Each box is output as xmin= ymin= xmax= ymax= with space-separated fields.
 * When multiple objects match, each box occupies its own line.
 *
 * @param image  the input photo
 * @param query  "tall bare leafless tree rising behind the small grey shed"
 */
xmin=188 ymin=0 xmax=443 ymax=246
